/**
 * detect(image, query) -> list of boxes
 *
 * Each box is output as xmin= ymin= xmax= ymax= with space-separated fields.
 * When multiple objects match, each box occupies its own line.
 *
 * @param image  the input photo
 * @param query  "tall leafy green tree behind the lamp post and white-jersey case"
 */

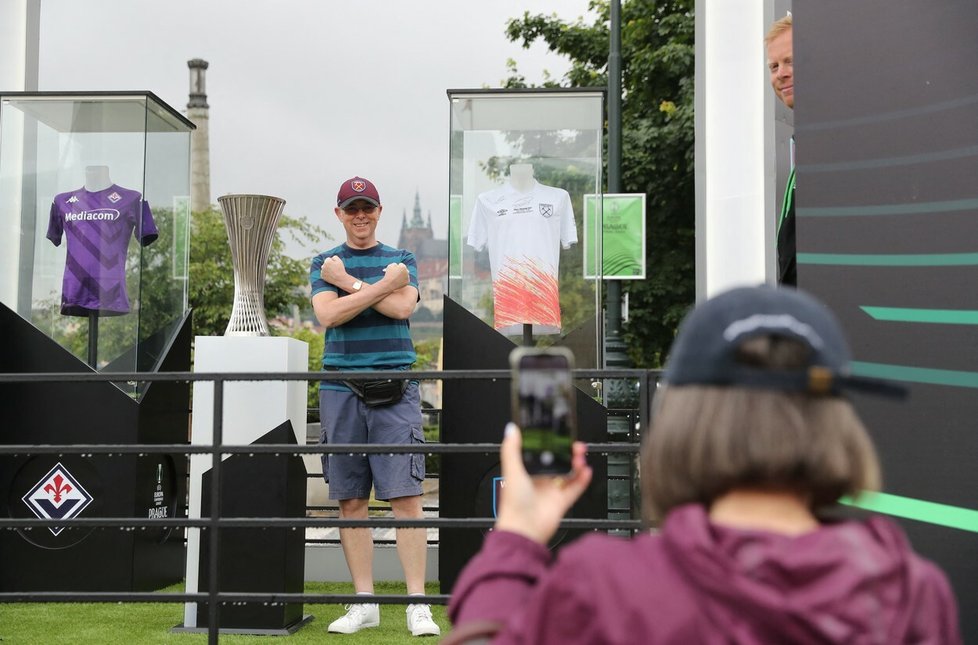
xmin=505 ymin=0 xmax=695 ymax=367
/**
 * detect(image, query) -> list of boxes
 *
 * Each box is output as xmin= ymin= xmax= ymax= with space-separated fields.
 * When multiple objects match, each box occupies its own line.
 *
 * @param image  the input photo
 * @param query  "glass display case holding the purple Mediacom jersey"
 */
xmin=0 ymin=92 xmax=194 ymax=397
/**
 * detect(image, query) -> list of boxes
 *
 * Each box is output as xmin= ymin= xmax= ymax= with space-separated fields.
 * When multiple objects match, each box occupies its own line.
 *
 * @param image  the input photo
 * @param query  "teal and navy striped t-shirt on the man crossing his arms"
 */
xmin=309 ymin=244 xmax=418 ymax=390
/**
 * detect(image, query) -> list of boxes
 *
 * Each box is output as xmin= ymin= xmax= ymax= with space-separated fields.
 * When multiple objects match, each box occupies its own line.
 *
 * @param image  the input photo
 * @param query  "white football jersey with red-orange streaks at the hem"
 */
xmin=468 ymin=181 xmax=577 ymax=334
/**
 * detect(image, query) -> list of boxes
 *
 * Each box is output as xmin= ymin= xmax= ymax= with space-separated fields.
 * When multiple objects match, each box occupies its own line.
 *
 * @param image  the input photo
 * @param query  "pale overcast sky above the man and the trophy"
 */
xmin=39 ymin=0 xmax=591 ymax=254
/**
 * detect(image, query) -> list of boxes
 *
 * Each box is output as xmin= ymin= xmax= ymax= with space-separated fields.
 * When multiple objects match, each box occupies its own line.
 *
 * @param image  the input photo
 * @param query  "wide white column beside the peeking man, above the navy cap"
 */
xmin=695 ymin=0 xmax=775 ymax=300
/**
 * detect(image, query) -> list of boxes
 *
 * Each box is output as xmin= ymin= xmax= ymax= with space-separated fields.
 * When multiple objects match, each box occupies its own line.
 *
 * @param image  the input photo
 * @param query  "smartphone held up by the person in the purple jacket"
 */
xmin=509 ymin=347 xmax=577 ymax=475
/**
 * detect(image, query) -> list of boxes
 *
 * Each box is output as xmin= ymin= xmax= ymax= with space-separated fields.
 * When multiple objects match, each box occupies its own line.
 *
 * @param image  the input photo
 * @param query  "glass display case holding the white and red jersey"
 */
xmin=448 ymin=89 xmax=604 ymax=367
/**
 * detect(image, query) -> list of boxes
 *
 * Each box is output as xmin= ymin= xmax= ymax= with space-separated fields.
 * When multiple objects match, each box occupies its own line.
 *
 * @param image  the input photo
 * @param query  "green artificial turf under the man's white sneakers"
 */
xmin=0 ymin=582 xmax=449 ymax=645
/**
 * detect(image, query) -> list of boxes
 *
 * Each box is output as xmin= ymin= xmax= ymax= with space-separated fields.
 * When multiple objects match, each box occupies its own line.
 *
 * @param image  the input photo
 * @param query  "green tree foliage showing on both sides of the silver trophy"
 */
xmin=189 ymin=209 xmax=331 ymax=336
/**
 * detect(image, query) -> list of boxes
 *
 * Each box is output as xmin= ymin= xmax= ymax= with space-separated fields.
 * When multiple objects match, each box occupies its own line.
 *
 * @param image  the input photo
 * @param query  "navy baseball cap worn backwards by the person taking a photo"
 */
xmin=664 ymin=286 xmax=907 ymax=398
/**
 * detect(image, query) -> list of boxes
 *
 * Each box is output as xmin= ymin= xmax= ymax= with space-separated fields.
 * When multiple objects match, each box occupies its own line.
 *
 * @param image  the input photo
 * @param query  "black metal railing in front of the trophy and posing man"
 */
xmin=0 ymin=369 xmax=660 ymax=643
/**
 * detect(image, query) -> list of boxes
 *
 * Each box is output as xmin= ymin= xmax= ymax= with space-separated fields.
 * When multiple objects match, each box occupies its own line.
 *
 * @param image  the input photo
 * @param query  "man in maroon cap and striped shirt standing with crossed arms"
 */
xmin=309 ymin=177 xmax=440 ymax=636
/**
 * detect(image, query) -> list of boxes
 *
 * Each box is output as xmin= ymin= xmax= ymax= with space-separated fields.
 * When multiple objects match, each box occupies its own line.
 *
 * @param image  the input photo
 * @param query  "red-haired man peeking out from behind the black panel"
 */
xmin=764 ymin=14 xmax=798 ymax=287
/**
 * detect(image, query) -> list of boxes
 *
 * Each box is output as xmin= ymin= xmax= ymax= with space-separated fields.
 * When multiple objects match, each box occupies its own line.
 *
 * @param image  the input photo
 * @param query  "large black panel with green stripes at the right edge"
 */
xmin=794 ymin=0 xmax=978 ymax=642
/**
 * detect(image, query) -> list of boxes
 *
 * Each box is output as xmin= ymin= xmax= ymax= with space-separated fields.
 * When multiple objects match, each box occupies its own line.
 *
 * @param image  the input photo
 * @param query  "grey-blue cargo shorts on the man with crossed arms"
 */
xmin=319 ymin=383 xmax=425 ymax=501
